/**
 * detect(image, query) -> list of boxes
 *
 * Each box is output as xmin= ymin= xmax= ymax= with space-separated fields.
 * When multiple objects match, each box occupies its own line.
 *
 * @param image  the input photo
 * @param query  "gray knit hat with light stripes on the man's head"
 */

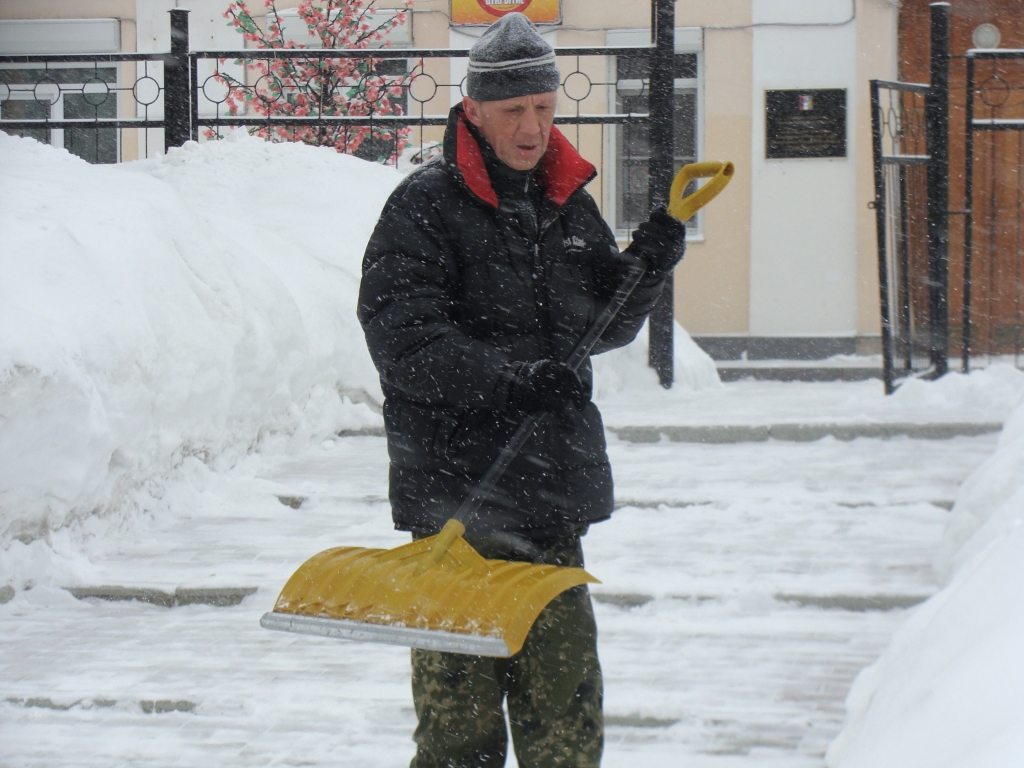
xmin=466 ymin=13 xmax=562 ymax=101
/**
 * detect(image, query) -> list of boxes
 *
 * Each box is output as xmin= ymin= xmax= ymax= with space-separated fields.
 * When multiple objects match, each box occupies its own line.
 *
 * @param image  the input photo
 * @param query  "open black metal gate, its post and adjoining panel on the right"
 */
xmin=871 ymin=4 xmax=1024 ymax=392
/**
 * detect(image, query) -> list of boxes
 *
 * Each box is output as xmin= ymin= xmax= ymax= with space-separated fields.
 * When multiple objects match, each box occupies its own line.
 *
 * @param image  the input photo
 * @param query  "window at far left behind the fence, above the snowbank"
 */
xmin=0 ymin=67 xmax=118 ymax=163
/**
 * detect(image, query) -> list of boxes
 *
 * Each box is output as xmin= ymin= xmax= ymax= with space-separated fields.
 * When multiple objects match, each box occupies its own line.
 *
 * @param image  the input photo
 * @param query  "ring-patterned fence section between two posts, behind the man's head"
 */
xmin=189 ymin=46 xmax=651 ymax=156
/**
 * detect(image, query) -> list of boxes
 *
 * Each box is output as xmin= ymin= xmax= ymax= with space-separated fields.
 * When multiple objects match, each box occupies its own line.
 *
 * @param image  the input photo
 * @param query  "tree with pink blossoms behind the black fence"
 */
xmin=214 ymin=0 xmax=412 ymax=161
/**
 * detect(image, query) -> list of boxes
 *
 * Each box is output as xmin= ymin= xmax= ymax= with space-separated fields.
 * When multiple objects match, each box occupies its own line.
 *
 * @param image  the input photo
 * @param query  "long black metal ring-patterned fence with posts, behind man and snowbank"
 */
xmin=0 ymin=0 xmax=684 ymax=387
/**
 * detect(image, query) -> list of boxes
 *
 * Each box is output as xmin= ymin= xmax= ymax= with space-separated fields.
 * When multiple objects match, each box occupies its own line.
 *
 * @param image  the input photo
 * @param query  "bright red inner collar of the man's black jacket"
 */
xmin=453 ymin=108 xmax=597 ymax=208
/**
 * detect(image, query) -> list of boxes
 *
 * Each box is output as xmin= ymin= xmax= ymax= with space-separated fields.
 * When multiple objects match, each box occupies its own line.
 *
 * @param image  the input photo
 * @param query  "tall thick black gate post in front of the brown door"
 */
xmin=925 ymin=3 xmax=949 ymax=377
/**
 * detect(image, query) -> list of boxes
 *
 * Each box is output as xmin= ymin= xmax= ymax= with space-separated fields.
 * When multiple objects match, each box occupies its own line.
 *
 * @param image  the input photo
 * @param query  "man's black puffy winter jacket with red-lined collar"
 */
xmin=358 ymin=106 xmax=663 ymax=541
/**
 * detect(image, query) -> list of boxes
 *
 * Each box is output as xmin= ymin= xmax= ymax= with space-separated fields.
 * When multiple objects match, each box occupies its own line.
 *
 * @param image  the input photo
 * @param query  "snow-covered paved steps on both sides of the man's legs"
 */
xmin=0 ymin=423 xmax=996 ymax=768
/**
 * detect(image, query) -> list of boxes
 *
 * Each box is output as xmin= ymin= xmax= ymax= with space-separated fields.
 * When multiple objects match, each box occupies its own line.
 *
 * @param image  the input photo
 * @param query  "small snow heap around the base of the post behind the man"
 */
xmin=592 ymin=323 xmax=722 ymax=403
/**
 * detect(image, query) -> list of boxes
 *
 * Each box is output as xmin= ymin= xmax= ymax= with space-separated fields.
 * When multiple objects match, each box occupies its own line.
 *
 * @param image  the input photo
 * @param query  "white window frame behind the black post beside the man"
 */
xmin=603 ymin=27 xmax=705 ymax=243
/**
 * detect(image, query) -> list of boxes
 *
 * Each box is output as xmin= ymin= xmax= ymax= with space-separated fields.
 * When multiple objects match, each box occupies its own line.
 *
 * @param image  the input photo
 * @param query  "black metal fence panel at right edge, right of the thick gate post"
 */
xmin=961 ymin=50 xmax=1024 ymax=372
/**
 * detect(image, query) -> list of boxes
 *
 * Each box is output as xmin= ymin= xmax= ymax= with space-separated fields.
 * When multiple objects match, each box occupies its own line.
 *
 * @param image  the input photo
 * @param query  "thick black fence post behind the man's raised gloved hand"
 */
xmin=648 ymin=0 xmax=676 ymax=389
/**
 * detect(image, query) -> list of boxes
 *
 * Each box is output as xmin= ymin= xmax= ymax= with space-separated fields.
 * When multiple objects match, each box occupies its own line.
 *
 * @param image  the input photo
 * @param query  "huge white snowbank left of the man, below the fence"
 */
xmin=0 ymin=134 xmax=401 ymax=554
